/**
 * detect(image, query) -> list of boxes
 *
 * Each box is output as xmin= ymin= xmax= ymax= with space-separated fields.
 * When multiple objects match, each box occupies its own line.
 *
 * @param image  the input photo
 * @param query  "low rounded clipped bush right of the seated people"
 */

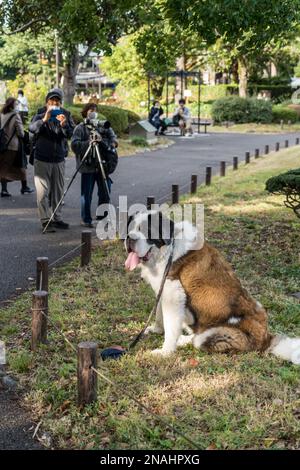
xmin=212 ymin=96 xmax=272 ymax=123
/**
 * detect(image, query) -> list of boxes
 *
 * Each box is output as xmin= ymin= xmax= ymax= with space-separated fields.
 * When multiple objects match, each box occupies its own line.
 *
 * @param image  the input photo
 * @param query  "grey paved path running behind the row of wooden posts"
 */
xmin=0 ymin=133 xmax=297 ymax=302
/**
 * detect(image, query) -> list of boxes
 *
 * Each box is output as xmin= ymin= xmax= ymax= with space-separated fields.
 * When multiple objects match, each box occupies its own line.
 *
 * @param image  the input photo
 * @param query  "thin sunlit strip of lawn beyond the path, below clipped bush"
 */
xmin=208 ymin=123 xmax=300 ymax=134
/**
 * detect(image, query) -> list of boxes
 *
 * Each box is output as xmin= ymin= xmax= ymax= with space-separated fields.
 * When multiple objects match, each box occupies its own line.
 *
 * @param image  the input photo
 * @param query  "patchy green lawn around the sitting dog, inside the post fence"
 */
xmin=0 ymin=148 xmax=300 ymax=449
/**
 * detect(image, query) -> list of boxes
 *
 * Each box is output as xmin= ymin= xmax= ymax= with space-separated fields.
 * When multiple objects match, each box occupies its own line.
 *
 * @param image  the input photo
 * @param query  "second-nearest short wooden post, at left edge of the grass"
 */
xmin=31 ymin=290 xmax=48 ymax=351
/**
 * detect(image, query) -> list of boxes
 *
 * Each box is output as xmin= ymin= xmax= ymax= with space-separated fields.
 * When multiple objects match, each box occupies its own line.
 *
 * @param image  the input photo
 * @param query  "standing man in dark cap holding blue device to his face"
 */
xmin=29 ymin=88 xmax=75 ymax=232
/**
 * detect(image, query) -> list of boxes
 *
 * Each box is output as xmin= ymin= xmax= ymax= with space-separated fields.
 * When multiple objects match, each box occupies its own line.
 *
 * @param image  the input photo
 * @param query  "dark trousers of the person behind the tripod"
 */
xmin=81 ymin=172 xmax=112 ymax=224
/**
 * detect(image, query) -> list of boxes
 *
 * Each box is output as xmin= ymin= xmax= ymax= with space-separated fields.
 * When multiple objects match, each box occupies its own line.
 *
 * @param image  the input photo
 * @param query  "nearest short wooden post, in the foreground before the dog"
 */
xmin=77 ymin=341 xmax=98 ymax=406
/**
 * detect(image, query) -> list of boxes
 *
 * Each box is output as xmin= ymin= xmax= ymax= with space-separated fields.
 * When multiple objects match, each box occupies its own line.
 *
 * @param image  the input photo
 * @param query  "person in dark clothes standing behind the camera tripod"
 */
xmin=71 ymin=103 xmax=118 ymax=228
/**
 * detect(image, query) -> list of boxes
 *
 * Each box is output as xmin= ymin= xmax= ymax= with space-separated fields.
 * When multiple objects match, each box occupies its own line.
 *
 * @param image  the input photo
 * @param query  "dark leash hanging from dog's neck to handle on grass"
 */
xmin=101 ymin=238 xmax=175 ymax=360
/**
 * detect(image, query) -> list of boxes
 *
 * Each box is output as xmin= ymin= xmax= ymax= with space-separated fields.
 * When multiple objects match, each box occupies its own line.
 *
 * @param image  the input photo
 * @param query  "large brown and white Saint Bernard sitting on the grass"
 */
xmin=125 ymin=211 xmax=300 ymax=364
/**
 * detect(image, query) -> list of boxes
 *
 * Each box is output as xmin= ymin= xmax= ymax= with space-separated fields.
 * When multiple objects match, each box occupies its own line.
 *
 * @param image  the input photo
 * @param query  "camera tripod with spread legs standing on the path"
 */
xmin=43 ymin=131 xmax=110 ymax=233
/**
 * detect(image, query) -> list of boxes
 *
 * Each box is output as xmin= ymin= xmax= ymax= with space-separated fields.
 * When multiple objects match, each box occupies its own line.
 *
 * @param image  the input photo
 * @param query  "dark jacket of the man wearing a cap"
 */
xmin=29 ymin=106 xmax=75 ymax=163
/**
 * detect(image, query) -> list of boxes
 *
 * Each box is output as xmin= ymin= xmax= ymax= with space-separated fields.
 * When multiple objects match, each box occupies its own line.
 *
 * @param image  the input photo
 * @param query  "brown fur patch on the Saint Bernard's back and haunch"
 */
xmin=168 ymin=243 xmax=272 ymax=352
